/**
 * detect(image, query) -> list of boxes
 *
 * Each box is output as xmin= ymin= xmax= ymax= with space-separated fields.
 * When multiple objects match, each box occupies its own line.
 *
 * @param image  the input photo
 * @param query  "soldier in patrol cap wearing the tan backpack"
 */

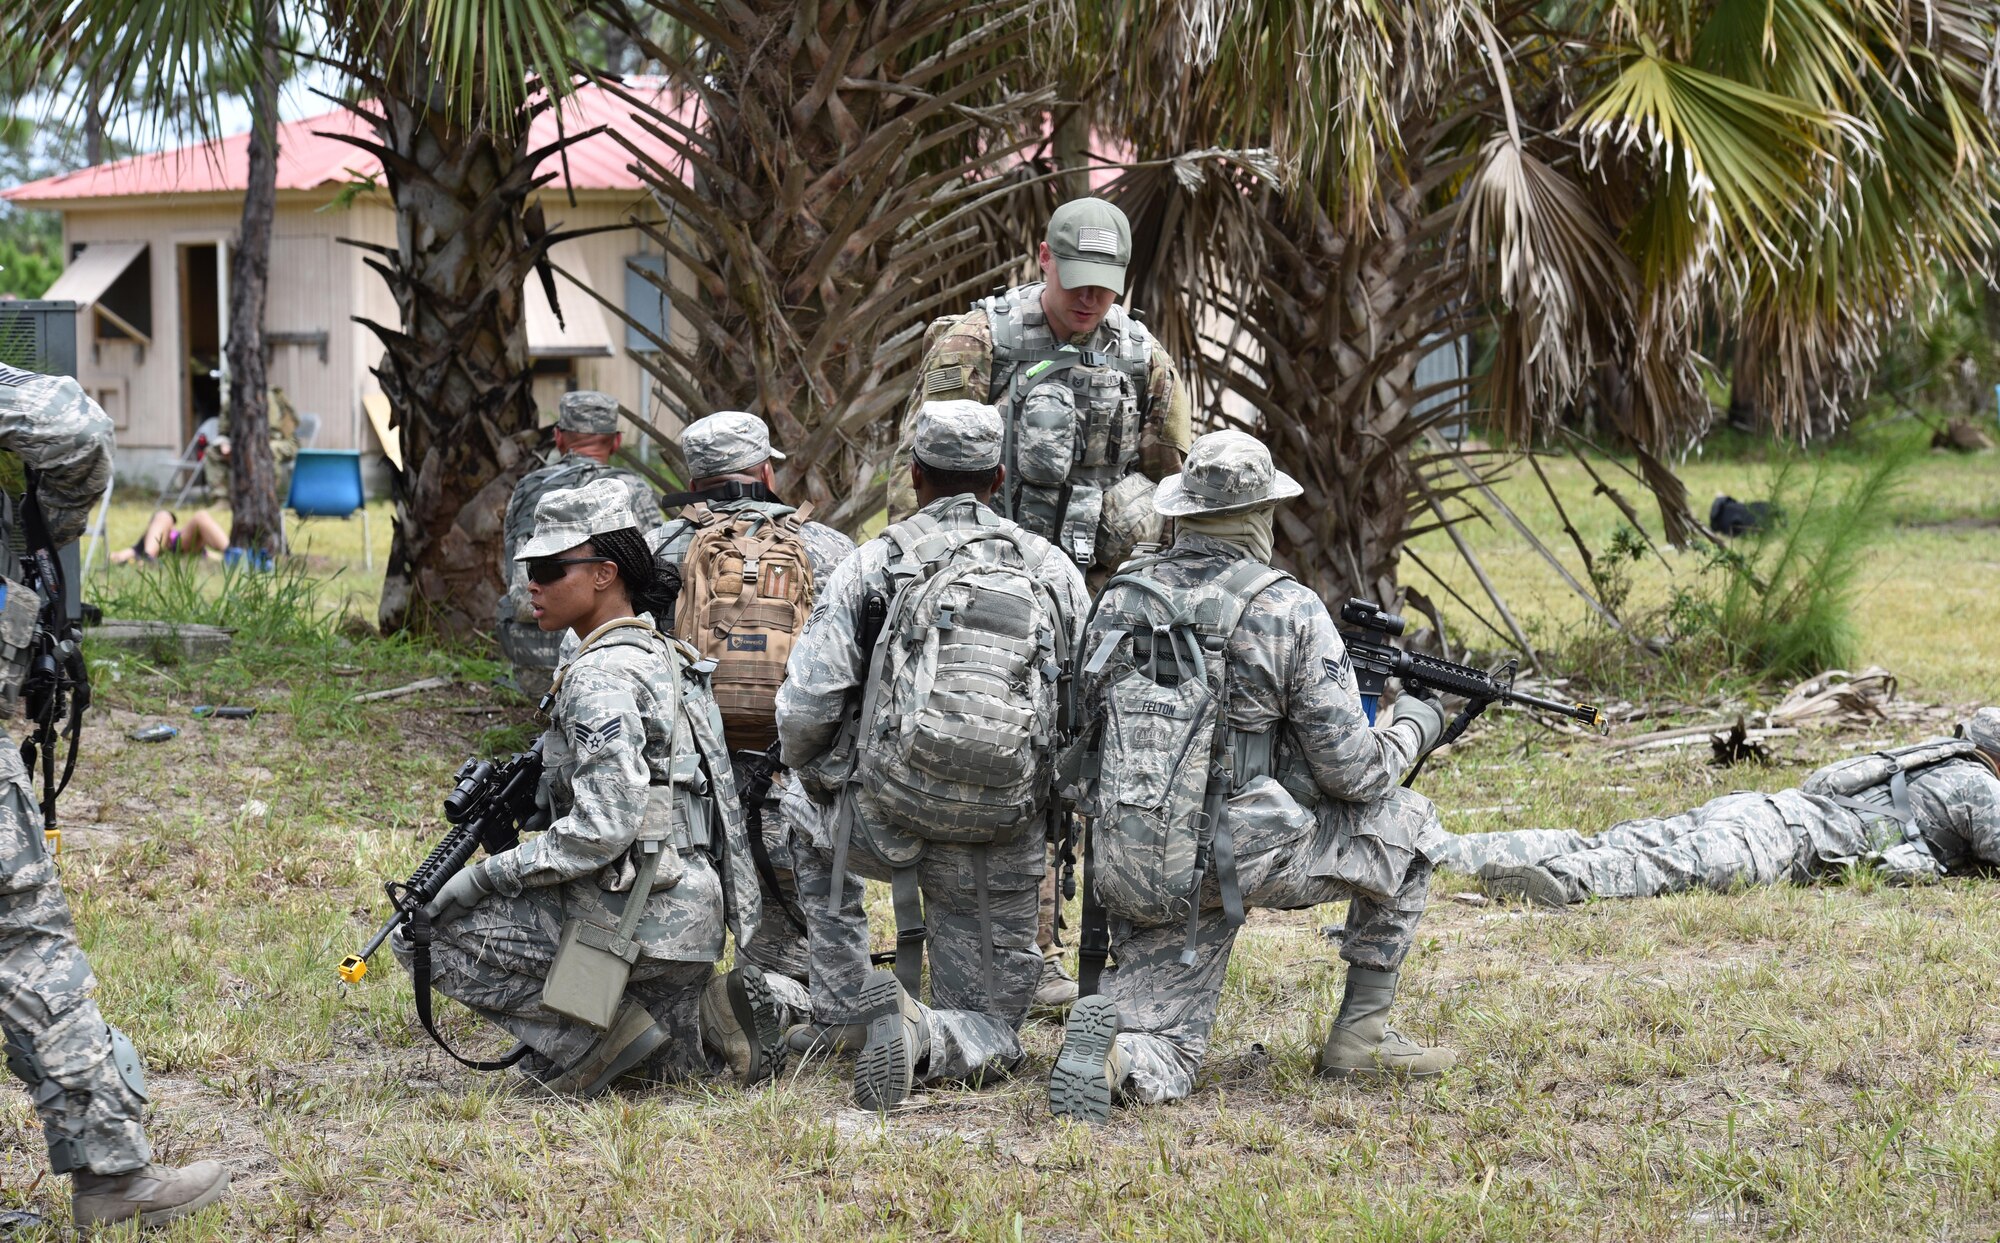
xmin=648 ymin=410 xmax=868 ymax=1051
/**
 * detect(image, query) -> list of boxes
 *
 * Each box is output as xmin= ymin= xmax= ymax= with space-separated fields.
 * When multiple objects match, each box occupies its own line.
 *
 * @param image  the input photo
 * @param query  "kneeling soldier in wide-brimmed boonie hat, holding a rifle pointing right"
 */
xmin=1050 ymin=432 xmax=1454 ymax=1121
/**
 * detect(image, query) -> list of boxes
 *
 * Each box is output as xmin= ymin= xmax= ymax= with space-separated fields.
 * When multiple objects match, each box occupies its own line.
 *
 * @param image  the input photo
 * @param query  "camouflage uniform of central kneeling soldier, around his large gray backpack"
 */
xmin=778 ymin=408 xmax=1088 ymax=1081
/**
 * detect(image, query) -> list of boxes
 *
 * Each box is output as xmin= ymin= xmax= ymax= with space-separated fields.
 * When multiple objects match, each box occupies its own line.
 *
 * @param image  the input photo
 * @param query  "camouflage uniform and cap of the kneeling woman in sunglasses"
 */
xmin=390 ymin=480 xmax=760 ymax=1079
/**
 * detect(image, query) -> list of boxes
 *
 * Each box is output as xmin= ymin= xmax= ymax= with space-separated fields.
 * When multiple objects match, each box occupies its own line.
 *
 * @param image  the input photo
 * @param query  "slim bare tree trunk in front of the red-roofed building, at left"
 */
xmin=228 ymin=0 xmax=284 ymax=554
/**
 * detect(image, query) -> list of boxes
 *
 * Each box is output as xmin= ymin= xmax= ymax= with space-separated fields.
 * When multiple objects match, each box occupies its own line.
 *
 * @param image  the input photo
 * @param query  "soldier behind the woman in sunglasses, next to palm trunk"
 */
xmin=494 ymin=390 xmax=662 ymax=699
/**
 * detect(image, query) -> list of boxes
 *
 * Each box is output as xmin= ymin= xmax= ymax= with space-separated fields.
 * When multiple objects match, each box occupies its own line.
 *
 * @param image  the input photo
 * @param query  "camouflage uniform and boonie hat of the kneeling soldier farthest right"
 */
xmin=1050 ymin=432 xmax=1446 ymax=1121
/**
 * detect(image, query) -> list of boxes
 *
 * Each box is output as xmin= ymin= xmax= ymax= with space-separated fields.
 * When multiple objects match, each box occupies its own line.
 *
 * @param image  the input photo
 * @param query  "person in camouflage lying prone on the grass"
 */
xmin=1440 ymin=707 xmax=2000 ymax=907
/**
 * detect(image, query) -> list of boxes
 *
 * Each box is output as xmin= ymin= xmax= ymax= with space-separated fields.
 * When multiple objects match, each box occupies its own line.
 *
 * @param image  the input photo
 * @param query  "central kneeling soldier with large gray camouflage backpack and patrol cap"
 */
xmin=778 ymin=400 xmax=1088 ymax=1109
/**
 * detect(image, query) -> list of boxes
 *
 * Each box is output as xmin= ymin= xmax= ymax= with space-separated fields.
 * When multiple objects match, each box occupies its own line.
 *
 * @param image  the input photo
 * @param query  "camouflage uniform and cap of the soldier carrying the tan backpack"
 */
xmin=648 ymin=412 xmax=852 ymax=1017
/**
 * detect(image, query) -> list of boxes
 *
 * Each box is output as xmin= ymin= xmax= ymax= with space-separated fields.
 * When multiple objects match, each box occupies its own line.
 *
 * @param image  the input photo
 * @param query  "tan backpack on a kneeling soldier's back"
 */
xmin=674 ymin=504 xmax=812 ymax=751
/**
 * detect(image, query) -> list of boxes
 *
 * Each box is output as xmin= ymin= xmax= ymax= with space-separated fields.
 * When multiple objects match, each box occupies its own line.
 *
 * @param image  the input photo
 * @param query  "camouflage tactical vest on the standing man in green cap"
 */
xmin=976 ymin=284 xmax=1152 ymax=566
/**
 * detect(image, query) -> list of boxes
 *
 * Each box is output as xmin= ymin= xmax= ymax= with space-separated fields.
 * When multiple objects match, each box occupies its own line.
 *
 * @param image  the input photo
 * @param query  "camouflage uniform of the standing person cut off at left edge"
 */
xmin=0 ymin=368 xmax=152 ymax=1175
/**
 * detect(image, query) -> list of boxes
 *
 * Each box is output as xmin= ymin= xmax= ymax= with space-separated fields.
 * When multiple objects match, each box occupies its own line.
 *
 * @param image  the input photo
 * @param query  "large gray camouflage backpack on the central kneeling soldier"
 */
xmin=856 ymin=510 xmax=1070 ymax=853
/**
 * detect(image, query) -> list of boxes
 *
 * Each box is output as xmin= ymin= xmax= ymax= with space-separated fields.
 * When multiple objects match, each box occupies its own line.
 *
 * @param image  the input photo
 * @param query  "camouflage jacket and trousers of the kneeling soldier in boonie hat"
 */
xmin=1082 ymin=534 xmax=1446 ymax=1103
